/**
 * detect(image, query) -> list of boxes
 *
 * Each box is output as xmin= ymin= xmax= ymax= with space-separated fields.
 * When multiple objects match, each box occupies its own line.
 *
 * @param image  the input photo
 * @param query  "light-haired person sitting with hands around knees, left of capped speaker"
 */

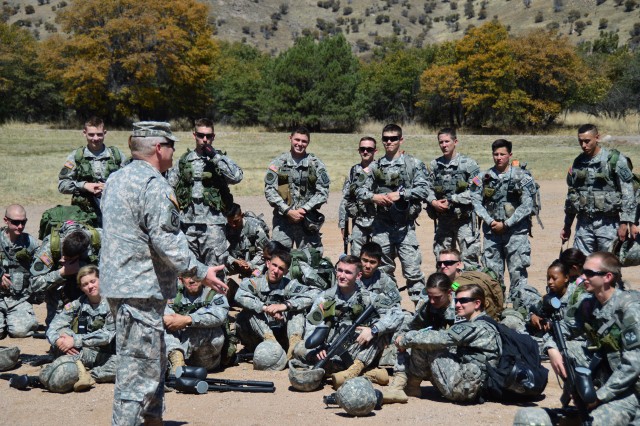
xmin=47 ymin=265 xmax=116 ymax=391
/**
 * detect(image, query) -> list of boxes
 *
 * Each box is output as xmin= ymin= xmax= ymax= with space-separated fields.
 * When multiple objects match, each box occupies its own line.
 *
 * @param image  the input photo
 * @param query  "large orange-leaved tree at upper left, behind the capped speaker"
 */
xmin=41 ymin=0 xmax=219 ymax=122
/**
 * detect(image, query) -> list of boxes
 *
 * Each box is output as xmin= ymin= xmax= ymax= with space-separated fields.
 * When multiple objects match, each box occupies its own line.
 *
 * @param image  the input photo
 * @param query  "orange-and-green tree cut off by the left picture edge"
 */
xmin=0 ymin=22 xmax=65 ymax=122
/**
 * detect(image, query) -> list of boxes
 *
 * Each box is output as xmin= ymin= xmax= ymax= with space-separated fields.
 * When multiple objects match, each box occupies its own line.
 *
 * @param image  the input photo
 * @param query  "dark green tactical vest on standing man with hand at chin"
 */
xmin=175 ymin=150 xmax=233 ymax=214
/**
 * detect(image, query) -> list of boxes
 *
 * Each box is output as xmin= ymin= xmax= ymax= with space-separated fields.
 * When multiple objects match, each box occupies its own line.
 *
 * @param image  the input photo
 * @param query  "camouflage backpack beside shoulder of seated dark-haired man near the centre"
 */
xmin=289 ymin=247 xmax=336 ymax=290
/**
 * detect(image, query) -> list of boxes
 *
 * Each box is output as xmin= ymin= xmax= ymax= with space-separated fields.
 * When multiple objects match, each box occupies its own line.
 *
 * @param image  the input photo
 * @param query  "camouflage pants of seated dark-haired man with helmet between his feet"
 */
xmin=236 ymin=309 xmax=305 ymax=350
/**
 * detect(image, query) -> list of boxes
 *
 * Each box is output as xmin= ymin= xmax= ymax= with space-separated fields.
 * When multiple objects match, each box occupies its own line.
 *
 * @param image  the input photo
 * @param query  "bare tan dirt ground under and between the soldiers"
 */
xmin=0 ymin=181 xmax=639 ymax=426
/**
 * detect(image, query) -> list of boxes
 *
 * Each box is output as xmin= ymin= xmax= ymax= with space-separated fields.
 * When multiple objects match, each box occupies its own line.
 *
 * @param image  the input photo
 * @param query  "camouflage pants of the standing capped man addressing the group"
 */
xmin=108 ymin=298 xmax=167 ymax=425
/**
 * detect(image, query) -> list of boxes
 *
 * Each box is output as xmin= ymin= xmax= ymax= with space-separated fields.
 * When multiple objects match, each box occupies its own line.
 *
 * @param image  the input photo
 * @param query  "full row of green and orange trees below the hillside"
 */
xmin=0 ymin=0 xmax=640 ymax=132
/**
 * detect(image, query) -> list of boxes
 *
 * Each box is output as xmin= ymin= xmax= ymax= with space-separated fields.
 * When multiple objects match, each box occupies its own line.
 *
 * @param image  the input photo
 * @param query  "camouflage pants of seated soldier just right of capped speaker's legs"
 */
xmin=164 ymin=327 xmax=224 ymax=370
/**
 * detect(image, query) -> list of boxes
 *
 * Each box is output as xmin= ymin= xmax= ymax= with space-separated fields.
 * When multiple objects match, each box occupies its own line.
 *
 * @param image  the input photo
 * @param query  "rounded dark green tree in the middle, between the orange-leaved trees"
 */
xmin=258 ymin=34 xmax=364 ymax=131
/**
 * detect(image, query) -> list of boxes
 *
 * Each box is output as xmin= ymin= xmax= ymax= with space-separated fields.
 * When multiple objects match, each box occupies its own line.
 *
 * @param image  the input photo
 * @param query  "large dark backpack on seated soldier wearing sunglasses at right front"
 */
xmin=478 ymin=315 xmax=549 ymax=401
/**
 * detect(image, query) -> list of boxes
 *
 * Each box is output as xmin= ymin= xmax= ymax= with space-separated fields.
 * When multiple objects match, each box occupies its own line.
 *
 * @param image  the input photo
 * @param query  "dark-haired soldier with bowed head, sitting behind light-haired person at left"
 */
xmin=31 ymin=221 xmax=102 ymax=326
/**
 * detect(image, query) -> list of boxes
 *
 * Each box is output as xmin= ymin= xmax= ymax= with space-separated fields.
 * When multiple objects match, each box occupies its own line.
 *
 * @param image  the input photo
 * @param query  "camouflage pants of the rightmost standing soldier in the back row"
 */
xmin=573 ymin=216 xmax=619 ymax=256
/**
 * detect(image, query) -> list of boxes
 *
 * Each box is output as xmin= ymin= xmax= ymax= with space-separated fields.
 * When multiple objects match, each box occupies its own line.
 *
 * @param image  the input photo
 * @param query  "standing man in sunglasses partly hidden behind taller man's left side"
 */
xmin=338 ymin=136 xmax=378 ymax=256
